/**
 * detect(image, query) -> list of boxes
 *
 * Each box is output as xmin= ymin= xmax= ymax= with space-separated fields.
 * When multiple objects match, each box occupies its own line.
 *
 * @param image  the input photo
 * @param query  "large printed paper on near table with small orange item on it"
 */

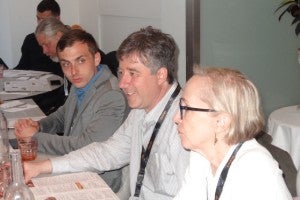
xmin=30 ymin=172 xmax=118 ymax=200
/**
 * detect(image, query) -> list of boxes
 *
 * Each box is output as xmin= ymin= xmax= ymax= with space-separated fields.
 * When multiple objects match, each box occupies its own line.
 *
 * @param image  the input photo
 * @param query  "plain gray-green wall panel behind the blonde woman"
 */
xmin=200 ymin=0 xmax=300 ymax=116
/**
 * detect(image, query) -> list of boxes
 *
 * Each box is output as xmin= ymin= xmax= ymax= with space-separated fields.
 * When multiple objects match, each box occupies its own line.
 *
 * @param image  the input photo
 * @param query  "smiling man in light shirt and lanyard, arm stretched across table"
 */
xmin=24 ymin=27 xmax=189 ymax=200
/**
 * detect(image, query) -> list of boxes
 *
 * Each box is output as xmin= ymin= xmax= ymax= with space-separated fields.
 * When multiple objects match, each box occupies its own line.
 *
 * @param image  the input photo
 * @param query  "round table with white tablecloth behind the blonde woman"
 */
xmin=268 ymin=106 xmax=300 ymax=170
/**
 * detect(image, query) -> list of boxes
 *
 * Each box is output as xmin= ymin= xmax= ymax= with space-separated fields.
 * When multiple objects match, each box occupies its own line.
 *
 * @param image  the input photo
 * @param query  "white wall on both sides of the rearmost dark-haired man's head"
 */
xmin=0 ymin=0 xmax=82 ymax=68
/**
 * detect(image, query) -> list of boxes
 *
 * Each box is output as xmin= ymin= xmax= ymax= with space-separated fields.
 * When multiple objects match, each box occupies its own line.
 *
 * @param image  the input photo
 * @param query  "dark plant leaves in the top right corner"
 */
xmin=275 ymin=0 xmax=300 ymax=36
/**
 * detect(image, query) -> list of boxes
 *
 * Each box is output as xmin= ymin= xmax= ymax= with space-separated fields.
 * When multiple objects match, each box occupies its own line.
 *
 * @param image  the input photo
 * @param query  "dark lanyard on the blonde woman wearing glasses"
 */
xmin=215 ymin=142 xmax=244 ymax=200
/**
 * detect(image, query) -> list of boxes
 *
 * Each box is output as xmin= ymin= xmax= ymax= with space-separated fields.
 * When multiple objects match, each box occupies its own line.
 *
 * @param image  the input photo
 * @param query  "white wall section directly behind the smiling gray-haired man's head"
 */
xmin=99 ymin=0 xmax=185 ymax=85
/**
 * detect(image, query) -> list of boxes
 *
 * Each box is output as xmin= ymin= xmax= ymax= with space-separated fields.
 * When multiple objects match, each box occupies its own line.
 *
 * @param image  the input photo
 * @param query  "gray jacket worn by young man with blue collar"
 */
xmin=36 ymin=66 xmax=128 ymax=155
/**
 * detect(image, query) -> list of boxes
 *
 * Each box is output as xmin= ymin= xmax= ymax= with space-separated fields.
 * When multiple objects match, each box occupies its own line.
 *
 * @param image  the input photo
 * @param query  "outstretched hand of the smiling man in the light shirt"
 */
xmin=23 ymin=160 xmax=52 ymax=183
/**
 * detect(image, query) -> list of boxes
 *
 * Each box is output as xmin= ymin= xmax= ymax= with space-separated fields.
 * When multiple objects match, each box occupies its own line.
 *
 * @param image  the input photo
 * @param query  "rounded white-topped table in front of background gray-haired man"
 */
xmin=0 ymin=70 xmax=64 ymax=101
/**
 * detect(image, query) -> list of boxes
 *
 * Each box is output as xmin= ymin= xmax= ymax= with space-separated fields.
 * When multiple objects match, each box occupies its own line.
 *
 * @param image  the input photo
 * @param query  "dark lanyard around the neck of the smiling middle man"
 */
xmin=134 ymin=84 xmax=181 ymax=197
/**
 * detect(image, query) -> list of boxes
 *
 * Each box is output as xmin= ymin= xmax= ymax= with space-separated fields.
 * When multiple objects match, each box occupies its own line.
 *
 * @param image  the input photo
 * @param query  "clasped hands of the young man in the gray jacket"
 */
xmin=14 ymin=119 xmax=40 ymax=138
